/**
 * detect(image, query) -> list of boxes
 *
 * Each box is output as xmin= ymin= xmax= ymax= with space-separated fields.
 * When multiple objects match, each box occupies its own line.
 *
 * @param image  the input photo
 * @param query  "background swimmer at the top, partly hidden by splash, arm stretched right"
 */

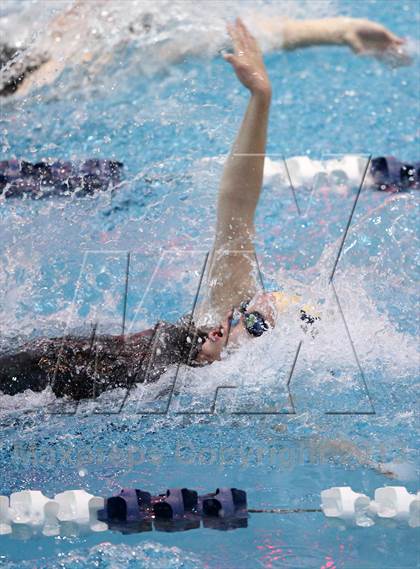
xmin=0 ymin=6 xmax=411 ymax=96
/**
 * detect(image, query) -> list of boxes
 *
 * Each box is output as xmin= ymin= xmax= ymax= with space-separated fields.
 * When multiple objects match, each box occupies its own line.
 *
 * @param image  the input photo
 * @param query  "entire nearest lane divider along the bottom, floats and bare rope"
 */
xmin=0 ymin=486 xmax=420 ymax=536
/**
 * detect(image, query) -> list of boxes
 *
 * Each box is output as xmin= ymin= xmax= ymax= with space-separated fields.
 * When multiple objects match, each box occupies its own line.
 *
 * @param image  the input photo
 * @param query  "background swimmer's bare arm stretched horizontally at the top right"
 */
xmin=256 ymin=17 xmax=410 ymax=65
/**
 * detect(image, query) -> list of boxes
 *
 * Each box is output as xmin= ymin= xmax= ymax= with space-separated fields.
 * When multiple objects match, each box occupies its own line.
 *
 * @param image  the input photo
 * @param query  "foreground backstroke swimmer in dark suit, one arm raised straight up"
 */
xmin=0 ymin=19 xmax=410 ymax=400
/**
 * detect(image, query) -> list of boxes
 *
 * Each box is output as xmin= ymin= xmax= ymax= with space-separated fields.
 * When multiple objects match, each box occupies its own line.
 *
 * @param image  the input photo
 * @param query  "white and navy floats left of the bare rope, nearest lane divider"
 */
xmin=0 ymin=488 xmax=248 ymax=536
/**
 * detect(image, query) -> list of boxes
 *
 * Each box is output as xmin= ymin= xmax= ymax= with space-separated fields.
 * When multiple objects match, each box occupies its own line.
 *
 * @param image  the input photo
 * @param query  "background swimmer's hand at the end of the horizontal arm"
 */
xmin=343 ymin=19 xmax=411 ymax=65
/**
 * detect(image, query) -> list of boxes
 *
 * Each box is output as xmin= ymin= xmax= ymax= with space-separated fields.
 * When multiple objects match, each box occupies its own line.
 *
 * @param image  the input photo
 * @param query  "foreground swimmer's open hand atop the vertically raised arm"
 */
xmin=223 ymin=18 xmax=271 ymax=97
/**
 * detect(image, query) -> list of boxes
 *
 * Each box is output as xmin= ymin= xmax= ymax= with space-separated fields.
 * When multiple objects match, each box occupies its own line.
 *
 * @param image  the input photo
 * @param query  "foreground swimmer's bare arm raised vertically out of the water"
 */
xmin=201 ymin=19 xmax=271 ymax=320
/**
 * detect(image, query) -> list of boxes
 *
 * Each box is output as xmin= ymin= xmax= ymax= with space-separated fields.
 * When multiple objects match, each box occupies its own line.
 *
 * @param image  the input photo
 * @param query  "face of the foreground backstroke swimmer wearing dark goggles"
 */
xmin=197 ymin=293 xmax=276 ymax=363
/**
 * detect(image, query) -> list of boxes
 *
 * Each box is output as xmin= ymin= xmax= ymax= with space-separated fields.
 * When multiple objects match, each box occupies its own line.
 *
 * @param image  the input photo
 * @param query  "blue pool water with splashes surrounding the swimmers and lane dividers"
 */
xmin=0 ymin=0 xmax=420 ymax=569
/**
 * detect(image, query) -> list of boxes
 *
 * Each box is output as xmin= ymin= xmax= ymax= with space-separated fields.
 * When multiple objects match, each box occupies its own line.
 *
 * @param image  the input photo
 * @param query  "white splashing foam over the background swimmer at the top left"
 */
xmin=0 ymin=0 xmax=336 ymax=95
